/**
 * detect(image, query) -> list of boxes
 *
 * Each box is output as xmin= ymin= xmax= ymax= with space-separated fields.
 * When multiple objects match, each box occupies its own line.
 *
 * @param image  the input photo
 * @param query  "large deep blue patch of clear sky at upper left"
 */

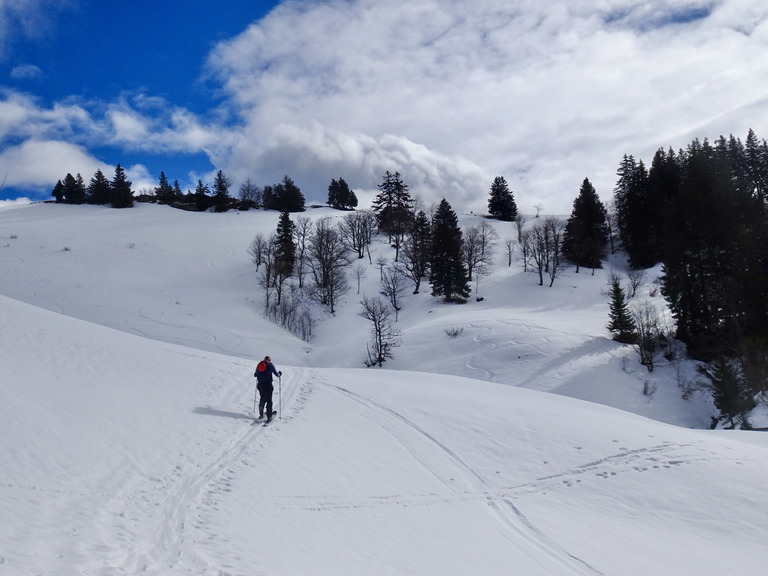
xmin=2 ymin=0 xmax=276 ymax=113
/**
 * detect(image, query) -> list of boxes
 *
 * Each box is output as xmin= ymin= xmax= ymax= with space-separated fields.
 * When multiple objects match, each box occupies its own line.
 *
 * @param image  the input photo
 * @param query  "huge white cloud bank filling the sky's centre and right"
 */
xmin=202 ymin=0 xmax=768 ymax=213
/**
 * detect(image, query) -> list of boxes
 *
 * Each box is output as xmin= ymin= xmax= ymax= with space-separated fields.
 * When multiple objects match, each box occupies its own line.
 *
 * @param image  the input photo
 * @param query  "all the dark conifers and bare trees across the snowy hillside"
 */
xmin=52 ymin=130 xmax=768 ymax=427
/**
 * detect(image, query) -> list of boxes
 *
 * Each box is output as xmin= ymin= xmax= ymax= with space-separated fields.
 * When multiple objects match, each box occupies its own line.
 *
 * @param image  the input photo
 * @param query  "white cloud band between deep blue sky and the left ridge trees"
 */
xmin=0 ymin=89 xmax=229 ymax=196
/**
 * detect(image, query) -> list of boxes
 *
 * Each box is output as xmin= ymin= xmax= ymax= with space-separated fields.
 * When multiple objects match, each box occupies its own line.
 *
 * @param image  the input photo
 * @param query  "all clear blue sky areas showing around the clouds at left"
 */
xmin=0 ymin=0 xmax=277 ymax=199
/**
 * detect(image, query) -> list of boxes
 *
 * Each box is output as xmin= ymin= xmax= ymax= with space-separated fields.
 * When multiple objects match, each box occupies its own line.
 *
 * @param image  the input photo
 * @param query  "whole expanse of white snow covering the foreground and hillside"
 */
xmin=0 ymin=205 xmax=768 ymax=576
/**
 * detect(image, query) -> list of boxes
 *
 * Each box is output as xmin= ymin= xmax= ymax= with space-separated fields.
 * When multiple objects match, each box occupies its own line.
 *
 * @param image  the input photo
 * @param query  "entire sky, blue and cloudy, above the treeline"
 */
xmin=0 ymin=0 xmax=768 ymax=214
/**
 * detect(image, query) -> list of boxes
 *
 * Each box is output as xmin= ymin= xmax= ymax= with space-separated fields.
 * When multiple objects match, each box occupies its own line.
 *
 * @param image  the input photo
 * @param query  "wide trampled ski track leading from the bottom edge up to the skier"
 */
xmin=82 ymin=369 xmax=309 ymax=576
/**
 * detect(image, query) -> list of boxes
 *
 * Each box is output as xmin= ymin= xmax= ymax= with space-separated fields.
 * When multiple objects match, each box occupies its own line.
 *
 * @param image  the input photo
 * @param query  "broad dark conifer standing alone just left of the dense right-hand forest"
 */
xmin=562 ymin=178 xmax=608 ymax=272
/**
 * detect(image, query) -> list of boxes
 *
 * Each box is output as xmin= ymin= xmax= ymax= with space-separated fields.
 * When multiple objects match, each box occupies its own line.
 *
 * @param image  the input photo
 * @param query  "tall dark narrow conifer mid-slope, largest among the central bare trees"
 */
xmin=429 ymin=198 xmax=470 ymax=302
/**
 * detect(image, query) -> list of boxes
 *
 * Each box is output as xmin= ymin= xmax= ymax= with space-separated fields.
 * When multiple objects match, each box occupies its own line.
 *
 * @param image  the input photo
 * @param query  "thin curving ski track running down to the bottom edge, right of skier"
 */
xmin=318 ymin=378 xmax=604 ymax=576
